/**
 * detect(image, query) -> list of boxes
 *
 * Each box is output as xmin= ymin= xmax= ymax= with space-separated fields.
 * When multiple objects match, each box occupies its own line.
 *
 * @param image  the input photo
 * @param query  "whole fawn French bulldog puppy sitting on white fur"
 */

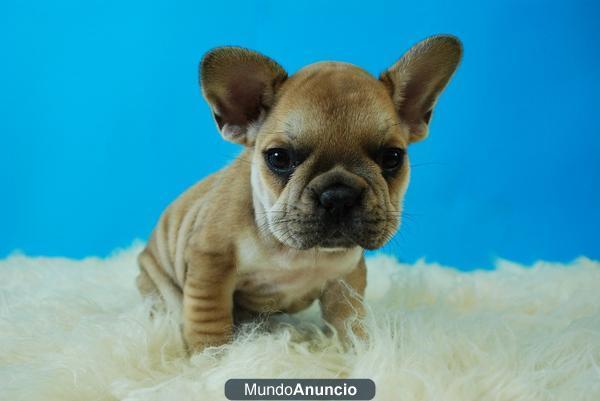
xmin=137 ymin=36 xmax=462 ymax=351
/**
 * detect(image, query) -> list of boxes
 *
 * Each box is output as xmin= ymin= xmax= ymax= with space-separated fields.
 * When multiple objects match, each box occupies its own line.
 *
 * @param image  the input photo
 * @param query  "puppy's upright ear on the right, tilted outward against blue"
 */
xmin=379 ymin=35 xmax=462 ymax=142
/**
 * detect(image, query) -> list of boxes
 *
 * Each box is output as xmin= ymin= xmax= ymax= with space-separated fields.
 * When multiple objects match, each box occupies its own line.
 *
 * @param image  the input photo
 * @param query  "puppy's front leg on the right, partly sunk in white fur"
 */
xmin=319 ymin=256 xmax=367 ymax=343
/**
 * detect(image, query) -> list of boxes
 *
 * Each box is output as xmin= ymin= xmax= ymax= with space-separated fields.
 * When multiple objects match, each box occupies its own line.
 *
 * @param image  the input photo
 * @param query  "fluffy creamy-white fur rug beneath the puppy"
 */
xmin=0 ymin=245 xmax=600 ymax=401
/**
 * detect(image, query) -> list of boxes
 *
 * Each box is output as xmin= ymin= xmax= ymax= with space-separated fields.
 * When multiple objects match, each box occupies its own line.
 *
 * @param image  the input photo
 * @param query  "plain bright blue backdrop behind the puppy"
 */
xmin=0 ymin=0 xmax=600 ymax=269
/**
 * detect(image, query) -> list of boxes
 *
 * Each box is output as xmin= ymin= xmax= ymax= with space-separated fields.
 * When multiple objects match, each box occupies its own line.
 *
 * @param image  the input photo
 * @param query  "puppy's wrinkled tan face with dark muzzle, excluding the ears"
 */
xmin=252 ymin=63 xmax=409 ymax=249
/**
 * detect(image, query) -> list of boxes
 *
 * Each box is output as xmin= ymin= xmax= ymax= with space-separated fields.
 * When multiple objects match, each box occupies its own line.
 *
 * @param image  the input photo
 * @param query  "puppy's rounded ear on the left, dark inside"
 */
xmin=200 ymin=47 xmax=287 ymax=146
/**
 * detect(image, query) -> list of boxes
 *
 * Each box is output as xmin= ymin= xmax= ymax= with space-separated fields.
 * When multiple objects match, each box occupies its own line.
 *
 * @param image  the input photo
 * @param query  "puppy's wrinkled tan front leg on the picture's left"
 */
xmin=183 ymin=247 xmax=235 ymax=352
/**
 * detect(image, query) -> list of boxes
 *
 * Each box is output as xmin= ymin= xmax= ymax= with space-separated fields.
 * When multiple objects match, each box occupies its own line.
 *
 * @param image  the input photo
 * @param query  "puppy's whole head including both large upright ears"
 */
xmin=200 ymin=36 xmax=461 ymax=249
